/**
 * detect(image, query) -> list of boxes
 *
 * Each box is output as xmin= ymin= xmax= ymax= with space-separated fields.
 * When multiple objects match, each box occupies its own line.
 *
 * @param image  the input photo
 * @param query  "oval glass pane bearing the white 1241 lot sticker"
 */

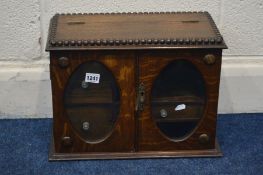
xmin=64 ymin=61 xmax=120 ymax=142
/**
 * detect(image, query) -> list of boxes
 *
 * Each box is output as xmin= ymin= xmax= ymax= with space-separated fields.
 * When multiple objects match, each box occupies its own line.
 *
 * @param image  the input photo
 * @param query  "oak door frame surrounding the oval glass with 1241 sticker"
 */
xmin=50 ymin=51 xmax=136 ymax=152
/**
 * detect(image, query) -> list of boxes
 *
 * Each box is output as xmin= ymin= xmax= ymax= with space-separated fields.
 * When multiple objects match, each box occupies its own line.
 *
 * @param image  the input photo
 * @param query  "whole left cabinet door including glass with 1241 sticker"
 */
xmin=51 ymin=52 xmax=135 ymax=152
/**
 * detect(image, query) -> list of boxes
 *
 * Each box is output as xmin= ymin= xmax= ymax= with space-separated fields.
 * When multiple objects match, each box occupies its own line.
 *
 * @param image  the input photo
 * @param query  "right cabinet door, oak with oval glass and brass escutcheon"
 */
xmin=139 ymin=51 xmax=221 ymax=151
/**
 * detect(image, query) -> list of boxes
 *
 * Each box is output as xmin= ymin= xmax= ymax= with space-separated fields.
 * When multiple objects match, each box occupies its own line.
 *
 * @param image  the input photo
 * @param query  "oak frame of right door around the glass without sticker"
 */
xmin=139 ymin=50 xmax=221 ymax=151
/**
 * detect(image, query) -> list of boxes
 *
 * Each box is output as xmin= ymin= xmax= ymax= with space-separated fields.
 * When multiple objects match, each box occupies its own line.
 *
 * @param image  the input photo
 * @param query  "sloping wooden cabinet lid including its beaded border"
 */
xmin=46 ymin=12 xmax=227 ymax=51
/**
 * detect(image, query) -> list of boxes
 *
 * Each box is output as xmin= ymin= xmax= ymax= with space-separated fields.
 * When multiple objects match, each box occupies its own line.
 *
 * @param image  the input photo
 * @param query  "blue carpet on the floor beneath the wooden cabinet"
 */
xmin=0 ymin=114 xmax=263 ymax=175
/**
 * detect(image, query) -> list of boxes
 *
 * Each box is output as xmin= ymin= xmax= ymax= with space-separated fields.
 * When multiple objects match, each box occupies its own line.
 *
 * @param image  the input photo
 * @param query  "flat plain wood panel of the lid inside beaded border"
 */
xmin=56 ymin=13 xmax=216 ymax=40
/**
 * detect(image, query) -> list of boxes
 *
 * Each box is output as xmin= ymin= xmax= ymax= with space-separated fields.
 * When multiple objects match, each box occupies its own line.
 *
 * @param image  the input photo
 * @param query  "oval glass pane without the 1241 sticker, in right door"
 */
xmin=151 ymin=60 xmax=206 ymax=140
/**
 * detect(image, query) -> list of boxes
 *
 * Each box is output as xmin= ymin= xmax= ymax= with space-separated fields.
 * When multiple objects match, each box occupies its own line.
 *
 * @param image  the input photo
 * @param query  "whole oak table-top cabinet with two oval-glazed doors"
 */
xmin=47 ymin=12 xmax=229 ymax=160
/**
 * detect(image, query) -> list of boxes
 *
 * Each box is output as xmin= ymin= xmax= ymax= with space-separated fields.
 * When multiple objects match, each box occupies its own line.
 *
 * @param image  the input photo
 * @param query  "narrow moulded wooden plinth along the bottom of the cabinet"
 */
xmin=49 ymin=139 xmax=223 ymax=161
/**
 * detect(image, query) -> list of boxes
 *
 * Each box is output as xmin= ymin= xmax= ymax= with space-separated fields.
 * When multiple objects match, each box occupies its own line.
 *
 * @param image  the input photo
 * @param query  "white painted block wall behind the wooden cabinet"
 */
xmin=0 ymin=0 xmax=263 ymax=118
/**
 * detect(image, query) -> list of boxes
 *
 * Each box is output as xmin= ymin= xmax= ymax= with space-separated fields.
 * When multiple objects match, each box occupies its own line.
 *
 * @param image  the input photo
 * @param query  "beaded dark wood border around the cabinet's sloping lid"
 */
xmin=46 ymin=11 xmax=227 ymax=51
